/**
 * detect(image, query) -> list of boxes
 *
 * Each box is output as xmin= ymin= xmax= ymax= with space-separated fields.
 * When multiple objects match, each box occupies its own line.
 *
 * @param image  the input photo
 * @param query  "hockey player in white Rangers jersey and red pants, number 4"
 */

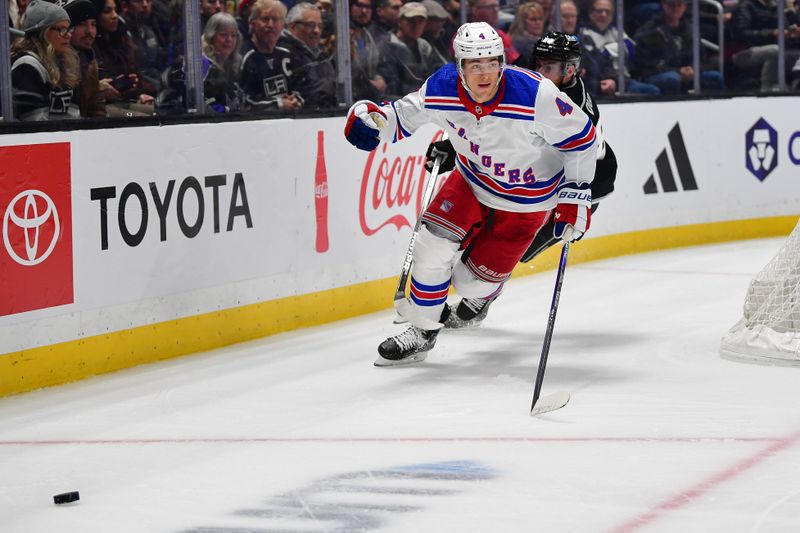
xmin=345 ymin=22 xmax=596 ymax=366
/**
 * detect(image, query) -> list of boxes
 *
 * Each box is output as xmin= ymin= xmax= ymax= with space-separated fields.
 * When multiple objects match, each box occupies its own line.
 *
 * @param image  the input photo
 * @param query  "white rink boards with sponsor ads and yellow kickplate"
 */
xmin=0 ymin=97 xmax=800 ymax=396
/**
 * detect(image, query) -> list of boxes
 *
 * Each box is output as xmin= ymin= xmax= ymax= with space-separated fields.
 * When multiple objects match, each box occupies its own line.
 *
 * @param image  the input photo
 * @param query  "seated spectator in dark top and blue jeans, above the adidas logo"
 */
xmin=634 ymin=0 xmax=724 ymax=95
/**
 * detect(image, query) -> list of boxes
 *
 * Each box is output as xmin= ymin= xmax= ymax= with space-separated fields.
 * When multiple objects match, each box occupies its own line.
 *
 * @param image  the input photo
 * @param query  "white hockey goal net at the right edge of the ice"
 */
xmin=720 ymin=218 xmax=800 ymax=366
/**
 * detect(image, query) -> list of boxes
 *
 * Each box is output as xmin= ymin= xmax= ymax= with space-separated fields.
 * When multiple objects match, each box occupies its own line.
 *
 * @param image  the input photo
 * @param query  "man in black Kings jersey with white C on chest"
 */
xmin=239 ymin=0 xmax=303 ymax=111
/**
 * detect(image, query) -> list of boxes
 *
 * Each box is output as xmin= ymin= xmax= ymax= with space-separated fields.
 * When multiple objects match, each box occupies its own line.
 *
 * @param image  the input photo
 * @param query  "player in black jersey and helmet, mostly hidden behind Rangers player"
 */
xmin=427 ymin=32 xmax=617 ymax=328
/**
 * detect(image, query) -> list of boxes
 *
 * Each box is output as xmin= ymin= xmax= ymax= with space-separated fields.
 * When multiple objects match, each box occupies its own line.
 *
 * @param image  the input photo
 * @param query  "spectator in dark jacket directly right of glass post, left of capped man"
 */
xmin=350 ymin=0 xmax=386 ymax=100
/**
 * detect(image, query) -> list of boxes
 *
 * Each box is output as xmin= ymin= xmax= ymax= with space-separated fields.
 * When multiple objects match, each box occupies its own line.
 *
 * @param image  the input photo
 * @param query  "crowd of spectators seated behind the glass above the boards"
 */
xmin=6 ymin=0 xmax=800 ymax=120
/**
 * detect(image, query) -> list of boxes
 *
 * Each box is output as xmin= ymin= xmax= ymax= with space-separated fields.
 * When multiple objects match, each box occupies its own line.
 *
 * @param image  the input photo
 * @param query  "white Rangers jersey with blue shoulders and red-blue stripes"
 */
xmin=380 ymin=64 xmax=597 ymax=212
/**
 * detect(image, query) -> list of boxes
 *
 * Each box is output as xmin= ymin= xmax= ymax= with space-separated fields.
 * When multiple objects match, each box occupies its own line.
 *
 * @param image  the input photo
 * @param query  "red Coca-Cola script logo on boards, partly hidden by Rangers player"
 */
xmin=358 ymin=130 xmax=444 ymax=236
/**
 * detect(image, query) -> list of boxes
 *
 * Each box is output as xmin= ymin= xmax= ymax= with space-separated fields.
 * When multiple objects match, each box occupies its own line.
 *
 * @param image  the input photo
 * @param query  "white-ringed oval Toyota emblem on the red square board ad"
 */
xmin=3 ymin=189 xmax=61 ymax=266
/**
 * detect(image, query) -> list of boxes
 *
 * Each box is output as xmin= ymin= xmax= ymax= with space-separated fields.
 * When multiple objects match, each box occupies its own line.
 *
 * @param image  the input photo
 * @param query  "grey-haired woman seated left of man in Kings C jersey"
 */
xmin=201 ymin=11 xmax=244 ymax=113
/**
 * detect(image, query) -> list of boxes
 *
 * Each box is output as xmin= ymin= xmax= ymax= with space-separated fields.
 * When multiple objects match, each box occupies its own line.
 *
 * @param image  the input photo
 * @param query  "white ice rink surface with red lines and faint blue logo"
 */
xmin=0 ymin=239 xmax=800 ymax=533
